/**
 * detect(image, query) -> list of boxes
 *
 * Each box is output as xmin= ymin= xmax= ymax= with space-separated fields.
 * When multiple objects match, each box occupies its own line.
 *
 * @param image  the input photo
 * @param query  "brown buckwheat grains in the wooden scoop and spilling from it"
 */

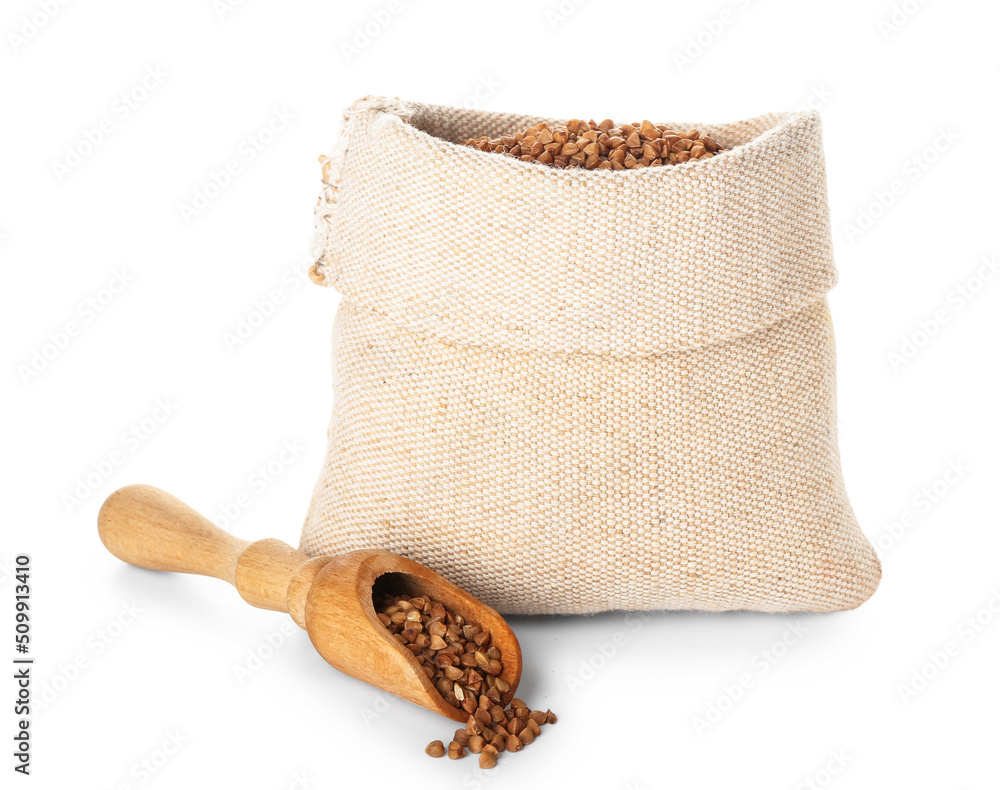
xmin=374 ymin=595 xmax=556 ymax=768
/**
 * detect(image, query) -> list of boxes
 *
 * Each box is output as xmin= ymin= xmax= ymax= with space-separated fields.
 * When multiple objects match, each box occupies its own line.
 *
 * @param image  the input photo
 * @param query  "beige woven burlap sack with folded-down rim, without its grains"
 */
xmin=302 ymin=98 xmax=880 ymax=614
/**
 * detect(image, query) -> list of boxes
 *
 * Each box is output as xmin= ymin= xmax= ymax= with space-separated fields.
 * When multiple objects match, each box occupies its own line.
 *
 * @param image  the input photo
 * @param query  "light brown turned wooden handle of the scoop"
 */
xmin=97 ymin=485 xmax=310 ymax=612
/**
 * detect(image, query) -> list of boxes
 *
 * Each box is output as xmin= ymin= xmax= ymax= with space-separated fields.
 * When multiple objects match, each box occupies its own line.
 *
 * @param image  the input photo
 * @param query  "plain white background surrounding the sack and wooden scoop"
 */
xmin=0 ymin=0 xmax=1000 ymax=790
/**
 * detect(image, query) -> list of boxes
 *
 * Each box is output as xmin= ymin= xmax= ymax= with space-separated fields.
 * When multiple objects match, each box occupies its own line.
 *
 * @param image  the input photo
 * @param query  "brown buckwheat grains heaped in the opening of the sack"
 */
xmin=465 ymin=119 xmax=724 ymax=170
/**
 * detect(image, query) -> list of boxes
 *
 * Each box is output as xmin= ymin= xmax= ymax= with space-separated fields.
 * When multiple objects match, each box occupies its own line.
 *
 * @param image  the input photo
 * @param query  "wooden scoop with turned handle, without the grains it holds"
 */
xmin=97 ymin=485 xmax=521 ymax=722
